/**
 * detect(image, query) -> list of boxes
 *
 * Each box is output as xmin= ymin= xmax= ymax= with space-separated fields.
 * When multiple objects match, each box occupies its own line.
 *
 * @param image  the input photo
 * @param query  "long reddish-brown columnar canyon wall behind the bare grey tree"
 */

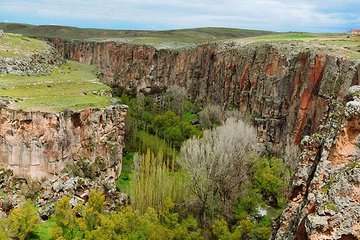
xmin=51 ymin=39 xmax=360 ymax=151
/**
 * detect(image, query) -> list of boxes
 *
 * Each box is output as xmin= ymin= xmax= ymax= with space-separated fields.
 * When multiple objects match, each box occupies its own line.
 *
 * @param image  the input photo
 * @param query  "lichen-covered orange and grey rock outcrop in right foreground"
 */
xmin=273 ymin=89 xmax=360 ymax=240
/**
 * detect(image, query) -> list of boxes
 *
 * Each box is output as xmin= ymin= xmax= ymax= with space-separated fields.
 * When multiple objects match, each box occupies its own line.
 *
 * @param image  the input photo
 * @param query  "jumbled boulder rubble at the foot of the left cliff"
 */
xmin=0 ymin=169 xmax=127 ymax=220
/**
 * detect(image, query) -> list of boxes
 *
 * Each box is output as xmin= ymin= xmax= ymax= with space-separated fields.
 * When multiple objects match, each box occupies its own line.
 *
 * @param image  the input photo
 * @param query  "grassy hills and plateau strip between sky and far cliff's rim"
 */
xmin=0 ymin=23 xmax=360 ymax=55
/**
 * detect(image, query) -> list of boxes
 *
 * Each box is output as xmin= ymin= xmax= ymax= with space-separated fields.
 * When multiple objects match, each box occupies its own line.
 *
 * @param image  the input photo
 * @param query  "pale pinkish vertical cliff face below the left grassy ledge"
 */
xmin=0 ymin=105 xmax=126 ymax=181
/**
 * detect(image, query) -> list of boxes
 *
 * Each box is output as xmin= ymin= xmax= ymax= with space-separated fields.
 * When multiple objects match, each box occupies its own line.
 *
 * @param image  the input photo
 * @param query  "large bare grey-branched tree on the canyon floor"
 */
xmin=179 ymin=118 xmax=256 ymax=223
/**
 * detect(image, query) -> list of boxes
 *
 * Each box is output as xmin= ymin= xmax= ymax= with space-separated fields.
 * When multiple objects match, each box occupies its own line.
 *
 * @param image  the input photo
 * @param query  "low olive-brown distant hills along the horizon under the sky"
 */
xmin=0 ymin=23 xmax=274 ymax=43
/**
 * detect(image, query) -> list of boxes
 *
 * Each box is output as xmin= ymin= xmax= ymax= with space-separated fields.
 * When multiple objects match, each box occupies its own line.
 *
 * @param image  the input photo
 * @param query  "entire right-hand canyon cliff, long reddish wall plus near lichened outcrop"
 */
xmin=51 ymin=39 xmax=360 ymax=239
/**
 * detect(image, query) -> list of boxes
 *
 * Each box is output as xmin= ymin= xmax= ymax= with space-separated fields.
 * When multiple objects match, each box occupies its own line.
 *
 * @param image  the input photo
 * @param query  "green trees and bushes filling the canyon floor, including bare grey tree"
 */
xmin=0 ymin=88 xmax=290 ymax=239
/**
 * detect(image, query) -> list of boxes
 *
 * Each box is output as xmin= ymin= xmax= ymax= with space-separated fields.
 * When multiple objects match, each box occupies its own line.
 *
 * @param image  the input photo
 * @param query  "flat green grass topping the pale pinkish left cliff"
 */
xmin=0 ymin=61 xmax=110 ymax=112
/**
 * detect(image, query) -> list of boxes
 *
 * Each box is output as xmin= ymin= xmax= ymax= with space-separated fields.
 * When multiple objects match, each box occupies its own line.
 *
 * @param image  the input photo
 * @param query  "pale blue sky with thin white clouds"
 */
xmin=0 ymin=0 xmax=360 ymax=32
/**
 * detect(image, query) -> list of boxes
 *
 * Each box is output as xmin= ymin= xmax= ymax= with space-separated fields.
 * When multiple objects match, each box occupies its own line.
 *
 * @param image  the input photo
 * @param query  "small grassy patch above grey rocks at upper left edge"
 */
xmin=0 ymin=34 xmax=48 ymax=59
